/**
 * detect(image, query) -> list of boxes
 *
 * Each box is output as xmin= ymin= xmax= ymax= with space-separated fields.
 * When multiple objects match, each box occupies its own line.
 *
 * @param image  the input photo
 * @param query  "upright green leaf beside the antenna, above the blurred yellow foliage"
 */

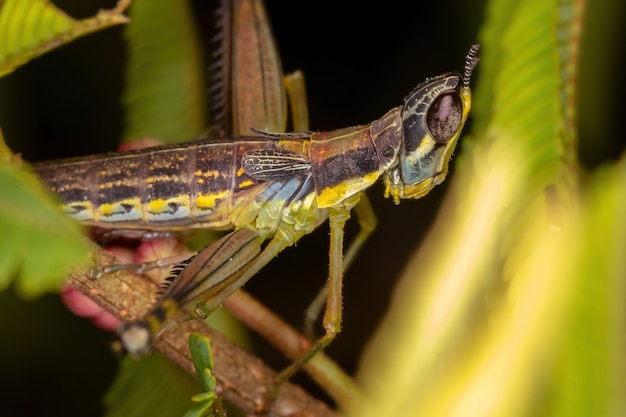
xmin=472 ymin=0 xmax=576 ymax=188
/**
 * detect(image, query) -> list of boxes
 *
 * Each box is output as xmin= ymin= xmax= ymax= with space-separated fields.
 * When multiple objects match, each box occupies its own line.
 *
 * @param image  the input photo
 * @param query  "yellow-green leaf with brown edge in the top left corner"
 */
xmin=0 ymin=0 xmax=129 ymax=76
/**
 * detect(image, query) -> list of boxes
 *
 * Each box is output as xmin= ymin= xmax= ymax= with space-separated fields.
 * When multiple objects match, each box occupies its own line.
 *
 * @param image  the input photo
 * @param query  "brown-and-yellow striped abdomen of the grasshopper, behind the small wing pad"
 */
xmin=34 ymin=138 xmax=273 ymax=230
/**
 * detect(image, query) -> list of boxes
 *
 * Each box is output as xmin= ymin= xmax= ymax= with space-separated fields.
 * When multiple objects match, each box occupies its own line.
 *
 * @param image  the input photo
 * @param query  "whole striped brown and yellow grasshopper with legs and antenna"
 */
xmin=34 ymin=0 xmax=478 ymax=396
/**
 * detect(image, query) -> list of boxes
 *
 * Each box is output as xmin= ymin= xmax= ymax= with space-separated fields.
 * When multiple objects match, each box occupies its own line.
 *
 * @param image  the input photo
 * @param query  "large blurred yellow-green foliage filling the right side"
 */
xmin=360 ymin=0 xmax=626 ymax=416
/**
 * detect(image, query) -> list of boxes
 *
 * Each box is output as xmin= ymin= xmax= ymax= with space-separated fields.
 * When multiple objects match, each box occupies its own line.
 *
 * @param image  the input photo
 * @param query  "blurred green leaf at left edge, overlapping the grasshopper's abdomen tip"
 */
xmin=0 ymin=164 xmax=89 ymax=297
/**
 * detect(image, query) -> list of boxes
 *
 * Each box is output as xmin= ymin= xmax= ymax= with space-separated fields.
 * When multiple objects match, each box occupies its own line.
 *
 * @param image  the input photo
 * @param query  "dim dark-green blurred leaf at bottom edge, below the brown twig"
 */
xmin=104 ymin=354 xmax=197 ymax=417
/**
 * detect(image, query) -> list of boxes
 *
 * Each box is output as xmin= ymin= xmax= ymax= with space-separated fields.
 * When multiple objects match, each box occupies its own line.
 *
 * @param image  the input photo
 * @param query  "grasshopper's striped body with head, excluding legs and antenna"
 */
xmin=34 ymin=68 xmax=470 ymax=244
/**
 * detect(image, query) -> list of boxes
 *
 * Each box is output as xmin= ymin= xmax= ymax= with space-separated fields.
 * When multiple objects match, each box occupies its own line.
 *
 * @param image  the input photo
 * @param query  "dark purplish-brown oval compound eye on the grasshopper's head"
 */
xmin=426 ymin=92 xmax=463 ymax=143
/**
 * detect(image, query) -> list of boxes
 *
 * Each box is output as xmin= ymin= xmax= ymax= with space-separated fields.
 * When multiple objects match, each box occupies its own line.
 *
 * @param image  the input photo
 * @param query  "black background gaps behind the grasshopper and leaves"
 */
xmin=0 ymin=0 xmax=625 ymax=416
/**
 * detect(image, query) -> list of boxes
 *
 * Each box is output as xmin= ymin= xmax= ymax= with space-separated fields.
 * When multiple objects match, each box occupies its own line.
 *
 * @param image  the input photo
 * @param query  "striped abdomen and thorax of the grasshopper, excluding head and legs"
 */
xmin=35 ymin=118 xmax=397 ymax=244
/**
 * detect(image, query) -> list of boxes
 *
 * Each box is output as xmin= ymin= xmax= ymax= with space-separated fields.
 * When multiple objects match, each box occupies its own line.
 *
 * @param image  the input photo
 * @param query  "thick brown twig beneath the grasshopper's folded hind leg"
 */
xmin=69 ymin=244 xmax=336 ymax=417
